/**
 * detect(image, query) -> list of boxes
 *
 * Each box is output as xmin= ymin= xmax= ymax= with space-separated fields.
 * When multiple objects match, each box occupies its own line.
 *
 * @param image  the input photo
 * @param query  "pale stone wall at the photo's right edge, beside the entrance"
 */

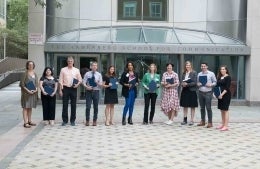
xmin=246 ymin=0 xmax=260 ymax=105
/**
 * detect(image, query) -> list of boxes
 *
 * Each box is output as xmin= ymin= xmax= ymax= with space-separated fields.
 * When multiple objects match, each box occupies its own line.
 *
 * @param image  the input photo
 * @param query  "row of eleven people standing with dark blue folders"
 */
xmin=20 ymin=57 xmax=231 ymax=131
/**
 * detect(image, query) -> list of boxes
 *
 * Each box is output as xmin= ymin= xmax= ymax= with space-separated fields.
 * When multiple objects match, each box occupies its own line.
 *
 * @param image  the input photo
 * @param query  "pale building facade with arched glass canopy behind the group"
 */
xmin=29 ymin=0 xmax=260 ymax=105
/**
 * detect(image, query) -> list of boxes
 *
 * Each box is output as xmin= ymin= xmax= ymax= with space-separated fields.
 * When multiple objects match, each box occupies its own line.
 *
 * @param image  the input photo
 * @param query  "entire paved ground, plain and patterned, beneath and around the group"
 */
xmin=0 ymin=83 xmax=260 ymax=169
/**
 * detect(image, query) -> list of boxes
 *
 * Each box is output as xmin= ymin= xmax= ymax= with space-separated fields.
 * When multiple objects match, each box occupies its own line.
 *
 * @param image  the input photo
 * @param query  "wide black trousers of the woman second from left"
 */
xmin=41 ymin=93 xmax=56 ymax=120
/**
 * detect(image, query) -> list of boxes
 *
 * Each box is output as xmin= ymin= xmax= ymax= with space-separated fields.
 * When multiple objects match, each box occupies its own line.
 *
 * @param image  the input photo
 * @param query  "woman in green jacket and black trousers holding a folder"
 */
xmin=142 ymin=63 xmax=160 ymax=125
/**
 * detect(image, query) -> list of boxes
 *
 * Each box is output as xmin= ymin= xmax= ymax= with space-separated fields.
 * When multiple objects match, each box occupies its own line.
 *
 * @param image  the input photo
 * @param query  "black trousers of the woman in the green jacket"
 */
xmin=143 ymin=93 xmax=157 ymax=123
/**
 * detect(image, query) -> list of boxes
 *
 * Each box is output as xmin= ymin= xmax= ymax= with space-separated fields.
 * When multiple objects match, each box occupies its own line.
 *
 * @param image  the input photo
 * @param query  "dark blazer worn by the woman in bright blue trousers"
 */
xmin=119 ymin=72 xmax=139 ymax=98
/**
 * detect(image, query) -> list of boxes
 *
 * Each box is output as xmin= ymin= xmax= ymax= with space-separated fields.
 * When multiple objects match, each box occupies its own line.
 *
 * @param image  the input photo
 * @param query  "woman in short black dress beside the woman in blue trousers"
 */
xmin=103 ymin=66 xmax=118 ymax=126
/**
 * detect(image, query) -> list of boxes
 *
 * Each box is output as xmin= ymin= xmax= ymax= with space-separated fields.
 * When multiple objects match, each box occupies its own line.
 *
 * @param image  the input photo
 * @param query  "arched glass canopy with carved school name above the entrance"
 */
xmin=45 ymin=26 xmax=250 ymax=55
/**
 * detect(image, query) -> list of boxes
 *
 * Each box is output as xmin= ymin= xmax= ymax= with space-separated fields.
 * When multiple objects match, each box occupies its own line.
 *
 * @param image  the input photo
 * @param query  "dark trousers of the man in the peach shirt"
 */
xmin=62 ymin=86 xmax=77 ymax=123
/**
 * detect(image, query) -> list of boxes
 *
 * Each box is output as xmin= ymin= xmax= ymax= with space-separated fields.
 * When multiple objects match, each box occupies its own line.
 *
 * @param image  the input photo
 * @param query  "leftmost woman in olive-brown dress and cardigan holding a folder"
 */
xmin=19 ymin=61 xmax=38 ymax=128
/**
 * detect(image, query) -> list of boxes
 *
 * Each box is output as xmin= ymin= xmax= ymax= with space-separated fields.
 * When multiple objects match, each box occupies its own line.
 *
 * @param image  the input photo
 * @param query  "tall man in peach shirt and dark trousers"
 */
xmin=59 ymin=56 xmax=82 ymax=126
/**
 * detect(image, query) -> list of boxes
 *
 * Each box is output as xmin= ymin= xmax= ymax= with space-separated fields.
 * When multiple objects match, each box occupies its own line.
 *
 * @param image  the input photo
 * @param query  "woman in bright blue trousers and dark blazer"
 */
xmin=120 ymin=61 xmax=139 ymax=125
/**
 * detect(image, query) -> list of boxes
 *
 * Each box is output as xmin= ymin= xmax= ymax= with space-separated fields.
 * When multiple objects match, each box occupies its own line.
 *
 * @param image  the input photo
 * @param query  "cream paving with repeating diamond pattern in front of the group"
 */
xmin=8 ymin=123 xmax=260 ymax=169
